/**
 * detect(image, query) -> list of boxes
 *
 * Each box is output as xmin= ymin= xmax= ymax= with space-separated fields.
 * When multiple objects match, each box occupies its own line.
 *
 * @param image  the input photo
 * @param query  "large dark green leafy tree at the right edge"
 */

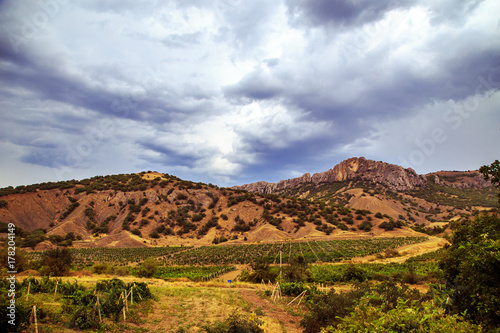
xmin=440 ymin=213 xmax=500 ymax=326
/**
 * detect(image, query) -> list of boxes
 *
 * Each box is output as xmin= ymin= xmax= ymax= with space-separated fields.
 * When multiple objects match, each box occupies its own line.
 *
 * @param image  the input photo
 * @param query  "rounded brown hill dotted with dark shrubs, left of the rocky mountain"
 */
xmin=0 ymin=172 xmax=424 ymax=249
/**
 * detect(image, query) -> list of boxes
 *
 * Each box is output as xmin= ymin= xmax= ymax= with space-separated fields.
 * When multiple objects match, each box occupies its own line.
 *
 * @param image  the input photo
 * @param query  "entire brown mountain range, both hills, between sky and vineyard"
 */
xmin=0 ymin=157 xmax=496 ymax=249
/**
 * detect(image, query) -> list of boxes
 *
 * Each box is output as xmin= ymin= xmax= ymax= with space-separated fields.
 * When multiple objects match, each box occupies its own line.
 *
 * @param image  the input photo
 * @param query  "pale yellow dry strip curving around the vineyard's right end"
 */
xmin=348 ymin=237 xmax=448 ymax=264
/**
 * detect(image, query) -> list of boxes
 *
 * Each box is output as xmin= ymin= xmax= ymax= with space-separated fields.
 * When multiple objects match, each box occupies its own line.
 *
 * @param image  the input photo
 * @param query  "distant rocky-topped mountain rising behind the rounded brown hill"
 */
xmin=234 ymin=157 xmax=496 ymax=210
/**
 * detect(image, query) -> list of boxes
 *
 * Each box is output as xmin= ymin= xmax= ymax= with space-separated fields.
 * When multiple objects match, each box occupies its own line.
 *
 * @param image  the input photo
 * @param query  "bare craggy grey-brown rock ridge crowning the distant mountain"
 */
xmin=236 ymin=157 xmax=427 ymax=193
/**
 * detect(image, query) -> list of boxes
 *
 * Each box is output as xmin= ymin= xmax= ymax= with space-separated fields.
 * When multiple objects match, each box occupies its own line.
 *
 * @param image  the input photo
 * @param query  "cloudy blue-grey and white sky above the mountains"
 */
xmin=0 ymin=0 xmax=500 ymax=187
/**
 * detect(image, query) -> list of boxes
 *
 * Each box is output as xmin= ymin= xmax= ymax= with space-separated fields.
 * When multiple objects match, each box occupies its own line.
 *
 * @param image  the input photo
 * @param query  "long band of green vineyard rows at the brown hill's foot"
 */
xmin=29 ymin=237 xmax=427 ymax=266
